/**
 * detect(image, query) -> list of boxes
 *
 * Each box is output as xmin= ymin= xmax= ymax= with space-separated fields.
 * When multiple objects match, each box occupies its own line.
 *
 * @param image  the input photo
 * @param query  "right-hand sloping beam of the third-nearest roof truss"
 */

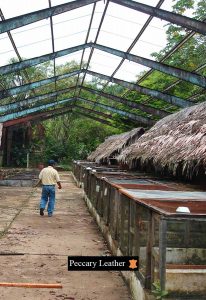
xmin=87 ymin=70 xmax=193 ymax=107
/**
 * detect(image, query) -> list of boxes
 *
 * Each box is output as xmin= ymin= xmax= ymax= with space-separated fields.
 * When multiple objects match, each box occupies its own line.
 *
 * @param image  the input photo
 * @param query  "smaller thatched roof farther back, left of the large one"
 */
xmin=87 ymin=127 xmax=144 ymax=163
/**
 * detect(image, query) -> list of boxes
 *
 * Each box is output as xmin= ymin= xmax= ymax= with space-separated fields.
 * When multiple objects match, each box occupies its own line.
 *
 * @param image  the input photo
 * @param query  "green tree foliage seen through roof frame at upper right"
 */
xmin=142 ymin=0 xmax=206 ymax=107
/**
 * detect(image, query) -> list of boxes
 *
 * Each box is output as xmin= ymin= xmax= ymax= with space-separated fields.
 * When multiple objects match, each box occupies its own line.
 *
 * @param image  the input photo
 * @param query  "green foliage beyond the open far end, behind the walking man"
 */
xmin=41 ymin=115 xmax=120 ymax=164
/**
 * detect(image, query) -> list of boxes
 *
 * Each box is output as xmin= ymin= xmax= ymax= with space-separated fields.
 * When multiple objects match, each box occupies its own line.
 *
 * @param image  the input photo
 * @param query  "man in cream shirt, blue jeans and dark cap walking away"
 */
xmin=39 ymin=160 xmax=62 ymax=217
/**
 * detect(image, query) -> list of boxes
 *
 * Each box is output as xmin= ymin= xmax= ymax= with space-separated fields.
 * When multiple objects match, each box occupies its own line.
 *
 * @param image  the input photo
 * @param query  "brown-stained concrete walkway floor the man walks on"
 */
xmin=0 ymin=173 xmax=130 ymax=300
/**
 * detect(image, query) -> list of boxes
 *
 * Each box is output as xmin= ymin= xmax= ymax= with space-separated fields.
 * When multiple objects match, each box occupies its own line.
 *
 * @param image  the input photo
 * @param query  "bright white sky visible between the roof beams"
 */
xmin=0 ymin=0 xmax=195 ymax=81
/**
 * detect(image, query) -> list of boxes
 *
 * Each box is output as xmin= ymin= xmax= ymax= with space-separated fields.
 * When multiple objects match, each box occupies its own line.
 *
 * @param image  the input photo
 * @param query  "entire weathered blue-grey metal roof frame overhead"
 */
xmin=0 ymin=0 xmax=206 ymax=126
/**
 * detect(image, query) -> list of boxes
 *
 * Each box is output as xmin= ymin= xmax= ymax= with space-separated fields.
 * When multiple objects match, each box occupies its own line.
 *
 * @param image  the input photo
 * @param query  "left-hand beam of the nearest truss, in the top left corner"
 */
xmin=0 ymin=0 xmax=99 ymax=33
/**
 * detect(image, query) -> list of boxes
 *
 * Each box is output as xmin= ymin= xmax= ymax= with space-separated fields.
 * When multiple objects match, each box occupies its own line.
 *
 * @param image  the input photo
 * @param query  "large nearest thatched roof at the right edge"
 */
xmin=117 ymin=102 xmax=206 ymax=179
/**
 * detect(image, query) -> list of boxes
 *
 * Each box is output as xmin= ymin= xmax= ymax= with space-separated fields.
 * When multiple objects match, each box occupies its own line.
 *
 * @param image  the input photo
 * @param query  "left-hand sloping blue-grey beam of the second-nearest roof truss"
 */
xmin=0 ymin=43 xmax=92 ymax=75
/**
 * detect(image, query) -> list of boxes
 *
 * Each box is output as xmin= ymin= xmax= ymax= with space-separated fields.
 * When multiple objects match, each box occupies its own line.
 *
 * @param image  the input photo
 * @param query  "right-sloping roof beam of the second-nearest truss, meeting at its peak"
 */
xmin=94 ymin=44 xmax=206 ymax=88
